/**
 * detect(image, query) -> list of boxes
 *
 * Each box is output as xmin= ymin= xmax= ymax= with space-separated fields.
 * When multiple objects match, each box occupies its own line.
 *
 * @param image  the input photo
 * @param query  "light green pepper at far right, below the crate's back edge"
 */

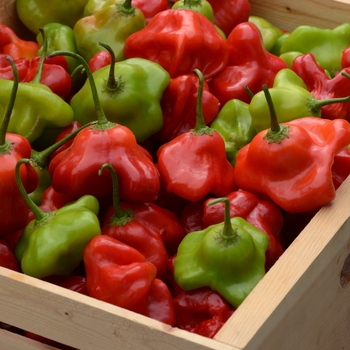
xmin=281 ymin=23 xmax=350 ymax=76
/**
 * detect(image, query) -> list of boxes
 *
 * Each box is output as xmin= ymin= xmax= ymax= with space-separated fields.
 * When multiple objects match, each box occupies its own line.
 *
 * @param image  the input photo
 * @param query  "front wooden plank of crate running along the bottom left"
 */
xmin=0 ymin=268 xmax=237 ymax=350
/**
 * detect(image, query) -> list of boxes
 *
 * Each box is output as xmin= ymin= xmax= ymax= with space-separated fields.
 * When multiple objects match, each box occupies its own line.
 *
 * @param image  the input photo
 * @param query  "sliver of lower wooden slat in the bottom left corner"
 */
xmin=0 ymin=329 xmax=58 ymax=350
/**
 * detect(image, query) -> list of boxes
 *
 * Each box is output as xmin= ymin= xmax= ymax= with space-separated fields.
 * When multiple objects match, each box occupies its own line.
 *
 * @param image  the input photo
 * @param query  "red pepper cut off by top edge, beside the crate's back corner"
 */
xmin=207 ymin=0 xmax=251 ymax=36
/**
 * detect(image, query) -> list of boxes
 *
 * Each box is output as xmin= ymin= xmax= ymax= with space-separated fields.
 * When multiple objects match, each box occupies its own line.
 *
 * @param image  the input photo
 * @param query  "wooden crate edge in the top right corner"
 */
xmin=249 ymin=0 xmax=350 ymax=30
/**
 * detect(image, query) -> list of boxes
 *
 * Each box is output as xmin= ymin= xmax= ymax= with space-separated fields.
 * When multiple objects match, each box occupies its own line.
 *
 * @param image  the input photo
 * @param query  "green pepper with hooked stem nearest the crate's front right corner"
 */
xmin=174 ymin=198 xmax=269 ymax=307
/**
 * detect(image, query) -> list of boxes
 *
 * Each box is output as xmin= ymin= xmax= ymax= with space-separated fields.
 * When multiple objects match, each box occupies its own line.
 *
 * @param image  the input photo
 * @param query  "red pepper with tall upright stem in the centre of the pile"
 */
xmin=157 ymin=69 xmax=235 ymax=202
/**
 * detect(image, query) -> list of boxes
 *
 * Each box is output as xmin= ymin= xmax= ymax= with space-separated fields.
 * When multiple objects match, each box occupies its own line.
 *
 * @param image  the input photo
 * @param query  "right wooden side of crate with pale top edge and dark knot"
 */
xmin=215 ymin=178 xmax=350 ymax=350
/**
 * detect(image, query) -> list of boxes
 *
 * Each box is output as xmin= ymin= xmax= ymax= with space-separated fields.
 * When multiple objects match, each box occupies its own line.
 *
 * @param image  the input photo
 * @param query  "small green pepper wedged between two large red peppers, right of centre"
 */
xmin=210 ymin=99 xmax=256 ymax=166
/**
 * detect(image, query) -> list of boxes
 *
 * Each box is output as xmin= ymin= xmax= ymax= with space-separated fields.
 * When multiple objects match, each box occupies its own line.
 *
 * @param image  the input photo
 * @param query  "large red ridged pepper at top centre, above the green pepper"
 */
xmin=124 ymin=0 xmax=228 ymax=79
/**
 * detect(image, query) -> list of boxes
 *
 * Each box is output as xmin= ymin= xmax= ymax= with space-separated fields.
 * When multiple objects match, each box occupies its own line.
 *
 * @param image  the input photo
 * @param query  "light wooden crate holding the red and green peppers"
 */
xmin=0 ymin=0 xmax=350 ymax=350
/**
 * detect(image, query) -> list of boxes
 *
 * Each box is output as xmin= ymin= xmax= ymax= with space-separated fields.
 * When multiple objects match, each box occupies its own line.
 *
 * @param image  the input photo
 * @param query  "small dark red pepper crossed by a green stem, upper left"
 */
xmin=24 ymin=56 xmax=72 ymax=99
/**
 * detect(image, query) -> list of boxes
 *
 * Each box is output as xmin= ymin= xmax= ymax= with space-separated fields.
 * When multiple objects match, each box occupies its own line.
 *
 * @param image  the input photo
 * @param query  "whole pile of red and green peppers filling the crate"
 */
xmin=0 ymin=0 xmax=350 ymax=345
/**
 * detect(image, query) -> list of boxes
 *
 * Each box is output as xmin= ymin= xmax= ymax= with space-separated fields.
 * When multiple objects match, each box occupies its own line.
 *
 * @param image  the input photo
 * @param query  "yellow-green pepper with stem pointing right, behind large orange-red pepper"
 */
xmin=249 ymin=68 xmax=350 ymax=132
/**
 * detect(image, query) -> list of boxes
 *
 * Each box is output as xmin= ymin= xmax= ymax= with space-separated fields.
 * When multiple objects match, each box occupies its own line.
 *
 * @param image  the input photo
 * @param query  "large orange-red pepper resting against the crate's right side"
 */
xmin=235 ymin=86 xmax=350 ymax=213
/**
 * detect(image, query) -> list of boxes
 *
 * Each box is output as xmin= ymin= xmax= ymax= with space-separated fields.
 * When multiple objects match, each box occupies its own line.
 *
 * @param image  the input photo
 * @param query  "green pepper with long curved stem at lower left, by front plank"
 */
xmin=15 ymin=158 xmax=101 ymax=278
